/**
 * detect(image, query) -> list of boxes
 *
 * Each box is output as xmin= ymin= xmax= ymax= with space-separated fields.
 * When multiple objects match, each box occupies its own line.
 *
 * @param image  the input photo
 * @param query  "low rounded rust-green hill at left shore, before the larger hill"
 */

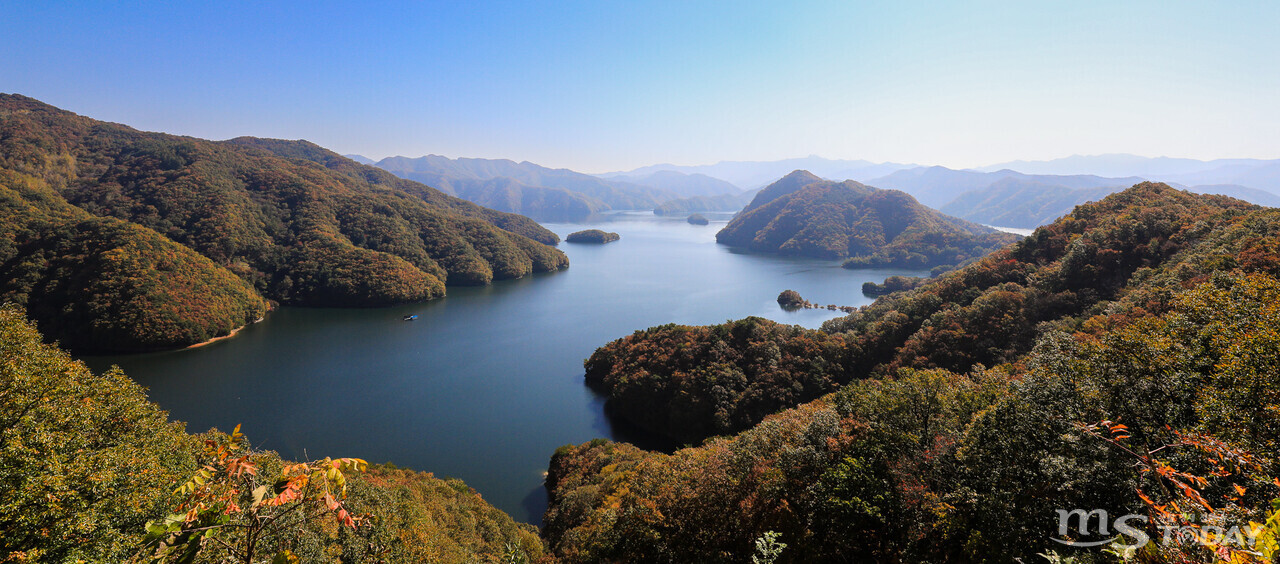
xmin=0 ymin=217 xmax=266 ymax=350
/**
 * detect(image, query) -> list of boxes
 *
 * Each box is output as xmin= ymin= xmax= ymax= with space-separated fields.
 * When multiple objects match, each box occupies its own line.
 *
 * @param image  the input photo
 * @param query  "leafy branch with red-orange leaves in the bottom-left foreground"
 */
xmin=136 ymin=425 xmax=369 ymax=564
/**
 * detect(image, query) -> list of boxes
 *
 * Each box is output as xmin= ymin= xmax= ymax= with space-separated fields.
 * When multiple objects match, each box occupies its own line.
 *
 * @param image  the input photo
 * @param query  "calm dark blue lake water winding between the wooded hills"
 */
xmin=86 ymin=212 xmax=927 ymax=523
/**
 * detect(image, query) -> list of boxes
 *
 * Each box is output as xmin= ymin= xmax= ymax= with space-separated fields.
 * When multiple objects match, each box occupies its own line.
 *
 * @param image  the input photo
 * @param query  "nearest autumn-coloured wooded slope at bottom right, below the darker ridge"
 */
xmin=545 ymin=272 xmax=1280 ymax=561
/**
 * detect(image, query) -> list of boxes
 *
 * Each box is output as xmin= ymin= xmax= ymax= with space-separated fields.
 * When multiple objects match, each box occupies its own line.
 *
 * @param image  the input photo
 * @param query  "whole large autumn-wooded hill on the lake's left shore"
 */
xmin=0 ymin=95 xmax=568 ymax=350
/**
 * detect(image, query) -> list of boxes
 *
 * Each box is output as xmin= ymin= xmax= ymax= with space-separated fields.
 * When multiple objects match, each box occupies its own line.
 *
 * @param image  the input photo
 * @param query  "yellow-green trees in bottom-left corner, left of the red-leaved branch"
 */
xmin=0 ymin=306 xmax=196 ymax=563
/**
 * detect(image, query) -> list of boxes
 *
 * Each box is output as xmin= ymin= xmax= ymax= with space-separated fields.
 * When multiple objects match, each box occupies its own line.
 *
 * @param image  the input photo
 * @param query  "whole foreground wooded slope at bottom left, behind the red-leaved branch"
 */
xmin=0 ymin=305 xmax=544 ymax=564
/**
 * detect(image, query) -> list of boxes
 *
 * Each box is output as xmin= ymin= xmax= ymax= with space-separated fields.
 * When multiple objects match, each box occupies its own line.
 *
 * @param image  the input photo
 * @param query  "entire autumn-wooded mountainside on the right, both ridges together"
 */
xmin=544 ymin=183 xmax=1280 ymax=563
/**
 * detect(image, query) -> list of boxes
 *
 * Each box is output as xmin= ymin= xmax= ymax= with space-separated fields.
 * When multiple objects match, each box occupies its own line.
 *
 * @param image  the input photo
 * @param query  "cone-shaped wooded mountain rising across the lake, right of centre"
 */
xmin=716 ymin=170 xmax=1018 ymax=267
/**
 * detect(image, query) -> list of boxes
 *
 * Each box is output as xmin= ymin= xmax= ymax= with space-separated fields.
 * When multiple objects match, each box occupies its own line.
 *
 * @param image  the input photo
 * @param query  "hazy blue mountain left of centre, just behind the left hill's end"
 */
xmin=378 ymin=155 xmax=686 ymax=221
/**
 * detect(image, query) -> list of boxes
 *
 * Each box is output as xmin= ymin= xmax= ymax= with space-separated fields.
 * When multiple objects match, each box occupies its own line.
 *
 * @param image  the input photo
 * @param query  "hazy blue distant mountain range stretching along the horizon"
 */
xmin=347 ymin=155 xmax=1280 ymax=229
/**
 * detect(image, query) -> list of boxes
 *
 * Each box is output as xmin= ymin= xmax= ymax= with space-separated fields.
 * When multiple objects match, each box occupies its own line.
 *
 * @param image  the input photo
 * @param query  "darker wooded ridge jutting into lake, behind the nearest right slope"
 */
xmin=586 ymin=183 xmax=1259 ymax=441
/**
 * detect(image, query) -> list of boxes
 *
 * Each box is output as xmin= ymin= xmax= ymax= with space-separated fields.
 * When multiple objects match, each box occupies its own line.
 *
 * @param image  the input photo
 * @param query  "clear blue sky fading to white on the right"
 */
xmin=0 ymin=0 xmax=1280 ymax=173
